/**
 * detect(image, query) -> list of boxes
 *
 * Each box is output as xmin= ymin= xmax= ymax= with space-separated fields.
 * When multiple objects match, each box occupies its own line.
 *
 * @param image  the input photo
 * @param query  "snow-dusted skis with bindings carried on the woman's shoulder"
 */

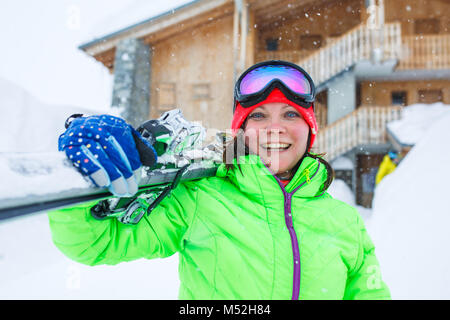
xmin=0 ymin=109 xmax=224 ymax=223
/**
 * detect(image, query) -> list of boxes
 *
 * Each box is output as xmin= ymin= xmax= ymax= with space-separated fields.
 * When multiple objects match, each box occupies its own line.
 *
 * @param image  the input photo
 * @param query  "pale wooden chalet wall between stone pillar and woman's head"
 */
xmin=150 ymin=15 xmax=233 ymax=130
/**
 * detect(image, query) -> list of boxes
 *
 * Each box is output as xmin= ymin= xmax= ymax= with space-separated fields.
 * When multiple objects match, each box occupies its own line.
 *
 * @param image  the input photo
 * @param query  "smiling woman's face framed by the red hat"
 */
xmin=244 ymin=102 xmax=309 ymax=175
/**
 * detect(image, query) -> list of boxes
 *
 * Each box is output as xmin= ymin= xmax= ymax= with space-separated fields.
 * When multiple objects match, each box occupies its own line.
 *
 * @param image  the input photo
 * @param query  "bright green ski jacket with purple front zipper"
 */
xmin=48 ymin=156 xmax=390 ymax=299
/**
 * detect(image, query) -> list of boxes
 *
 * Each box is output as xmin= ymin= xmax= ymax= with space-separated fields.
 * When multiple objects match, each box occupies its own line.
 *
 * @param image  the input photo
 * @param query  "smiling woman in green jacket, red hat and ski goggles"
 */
xmin=49 ymin=61 xmax=390 ymax=299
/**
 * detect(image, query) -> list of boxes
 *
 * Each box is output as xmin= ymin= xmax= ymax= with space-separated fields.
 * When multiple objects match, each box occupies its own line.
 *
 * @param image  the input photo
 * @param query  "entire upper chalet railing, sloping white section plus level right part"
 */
xmin=256 ymin=23 xmax=450 ymax=79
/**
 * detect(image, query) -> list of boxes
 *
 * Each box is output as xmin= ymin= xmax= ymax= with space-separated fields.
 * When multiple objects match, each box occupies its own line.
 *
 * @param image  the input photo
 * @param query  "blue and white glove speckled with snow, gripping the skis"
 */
xmin=58 ymin=114 xmax=157 ymax=197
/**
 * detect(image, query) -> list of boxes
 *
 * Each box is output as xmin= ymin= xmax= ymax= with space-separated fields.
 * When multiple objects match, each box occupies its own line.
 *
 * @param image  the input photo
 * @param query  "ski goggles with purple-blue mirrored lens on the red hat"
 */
xmin=234 ymin=60 xmax=316 ymax=108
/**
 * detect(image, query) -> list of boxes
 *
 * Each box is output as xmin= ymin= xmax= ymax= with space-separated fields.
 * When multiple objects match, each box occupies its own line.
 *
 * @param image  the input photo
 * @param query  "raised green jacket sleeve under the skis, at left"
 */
xmin=48 ymin=183 xmax=196 ymax=265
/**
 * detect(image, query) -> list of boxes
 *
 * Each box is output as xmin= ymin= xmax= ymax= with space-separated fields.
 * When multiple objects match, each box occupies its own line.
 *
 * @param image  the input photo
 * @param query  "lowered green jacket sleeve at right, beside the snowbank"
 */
xmin=344 ymin=214 xmax=391 ymax=300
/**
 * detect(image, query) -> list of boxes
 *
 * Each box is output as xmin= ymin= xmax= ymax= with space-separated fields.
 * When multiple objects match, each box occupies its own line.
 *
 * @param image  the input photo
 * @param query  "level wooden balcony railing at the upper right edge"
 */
xmin=397 ymin=34 xmax=450 ymax=70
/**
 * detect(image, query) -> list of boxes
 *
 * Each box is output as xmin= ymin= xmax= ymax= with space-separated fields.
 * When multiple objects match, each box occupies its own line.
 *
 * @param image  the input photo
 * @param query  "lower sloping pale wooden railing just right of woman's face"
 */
xmin=313 ymin=106 xmax=402 ymax=160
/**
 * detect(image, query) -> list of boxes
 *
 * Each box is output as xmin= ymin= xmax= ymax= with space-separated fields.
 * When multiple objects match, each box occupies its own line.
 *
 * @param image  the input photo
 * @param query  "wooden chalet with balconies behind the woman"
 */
xmin=80 ymin=0 xmax=450 ymax=206
